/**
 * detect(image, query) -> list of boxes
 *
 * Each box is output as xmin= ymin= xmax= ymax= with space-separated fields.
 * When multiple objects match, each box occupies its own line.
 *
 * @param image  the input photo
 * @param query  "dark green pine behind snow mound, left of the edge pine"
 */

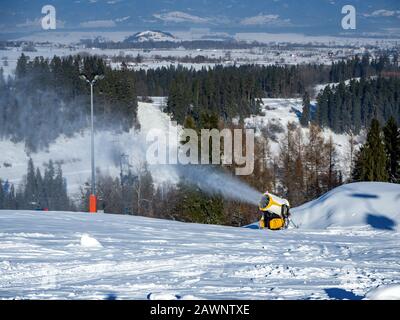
xmin=353 ymin=119 xmax=388 ymax=182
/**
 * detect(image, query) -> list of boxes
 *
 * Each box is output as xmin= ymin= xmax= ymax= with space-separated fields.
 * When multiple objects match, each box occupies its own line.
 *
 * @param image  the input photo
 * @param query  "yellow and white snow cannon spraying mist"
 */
xmin=258 ymin=191 xmax=290 ymax=230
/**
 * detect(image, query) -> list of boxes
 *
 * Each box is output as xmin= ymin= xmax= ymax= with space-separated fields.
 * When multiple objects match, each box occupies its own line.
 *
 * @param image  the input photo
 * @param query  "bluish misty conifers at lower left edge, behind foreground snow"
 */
xmin=0 ymin=159 xmax=76 ymax=211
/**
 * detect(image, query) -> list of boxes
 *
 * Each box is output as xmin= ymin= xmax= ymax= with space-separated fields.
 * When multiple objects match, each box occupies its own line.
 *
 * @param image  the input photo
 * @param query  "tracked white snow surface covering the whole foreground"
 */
xmin=0 ymin=211 xmax=400 ymax=299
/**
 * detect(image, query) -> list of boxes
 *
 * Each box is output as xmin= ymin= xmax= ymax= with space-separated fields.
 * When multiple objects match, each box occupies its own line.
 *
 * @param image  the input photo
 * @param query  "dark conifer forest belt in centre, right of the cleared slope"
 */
xmin=135 ymin=65 xmax=329 ymax=124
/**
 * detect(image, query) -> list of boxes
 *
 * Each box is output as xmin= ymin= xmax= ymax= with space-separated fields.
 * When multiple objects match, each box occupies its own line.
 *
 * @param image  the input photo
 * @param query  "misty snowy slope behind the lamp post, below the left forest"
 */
xmin=0 ymin=97 xmax=175 ymax=198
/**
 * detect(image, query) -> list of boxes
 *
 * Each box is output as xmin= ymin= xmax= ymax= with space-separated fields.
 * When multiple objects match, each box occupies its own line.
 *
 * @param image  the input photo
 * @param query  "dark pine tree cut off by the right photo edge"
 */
xmin=383 ymin=117 xmax=400 ymax=183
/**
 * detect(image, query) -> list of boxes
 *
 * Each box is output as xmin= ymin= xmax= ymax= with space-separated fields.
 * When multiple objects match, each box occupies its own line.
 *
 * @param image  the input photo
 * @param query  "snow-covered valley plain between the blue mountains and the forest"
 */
xmin=0 ymin=31 xmax=399 ymax=77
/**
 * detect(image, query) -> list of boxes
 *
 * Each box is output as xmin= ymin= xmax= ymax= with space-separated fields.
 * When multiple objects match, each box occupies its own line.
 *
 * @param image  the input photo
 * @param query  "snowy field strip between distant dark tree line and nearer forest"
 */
xmin=0 ymin=43 xmax=344 ymax=77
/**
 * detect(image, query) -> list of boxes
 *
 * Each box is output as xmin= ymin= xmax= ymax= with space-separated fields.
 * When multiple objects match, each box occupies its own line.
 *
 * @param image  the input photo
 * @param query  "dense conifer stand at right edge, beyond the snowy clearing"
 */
xmin=310 ymin=77 xmax=400 ymax=134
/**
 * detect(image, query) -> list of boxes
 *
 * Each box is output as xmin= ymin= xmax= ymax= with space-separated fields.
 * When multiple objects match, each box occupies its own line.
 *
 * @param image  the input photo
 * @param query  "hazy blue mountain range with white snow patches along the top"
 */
xmin=0 ymin=0 xmax=400 ymax=35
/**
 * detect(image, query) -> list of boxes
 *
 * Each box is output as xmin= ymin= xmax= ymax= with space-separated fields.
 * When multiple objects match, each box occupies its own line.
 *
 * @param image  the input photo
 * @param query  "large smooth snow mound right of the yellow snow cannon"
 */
xmin=292 ymin=182 xmax=400 ymax=231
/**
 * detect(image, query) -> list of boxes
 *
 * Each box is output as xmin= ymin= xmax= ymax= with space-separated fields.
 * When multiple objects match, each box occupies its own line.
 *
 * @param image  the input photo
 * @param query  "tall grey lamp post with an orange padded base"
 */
xmin=80 ymin=74 xmax=104 ymax=213
